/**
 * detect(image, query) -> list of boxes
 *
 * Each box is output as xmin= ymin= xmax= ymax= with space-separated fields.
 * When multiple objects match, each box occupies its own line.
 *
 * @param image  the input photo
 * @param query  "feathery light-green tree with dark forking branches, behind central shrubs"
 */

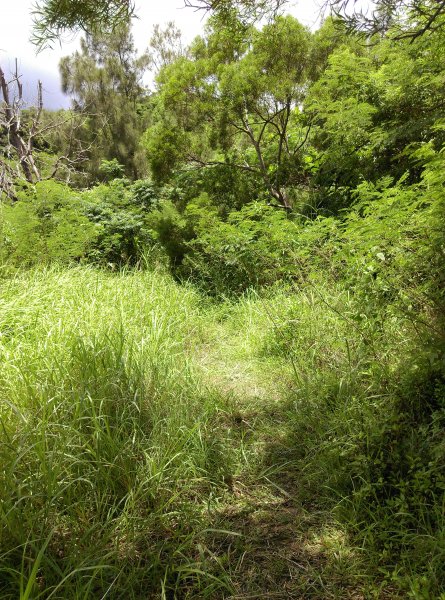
xmin=147 ymin=17 xmax=310 ymax=210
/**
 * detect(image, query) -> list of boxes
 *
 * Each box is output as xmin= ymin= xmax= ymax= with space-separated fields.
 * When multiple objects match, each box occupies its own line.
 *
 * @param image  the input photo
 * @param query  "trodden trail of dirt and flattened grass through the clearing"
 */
xmin=194 ymin=327 xmax=365 ymax=600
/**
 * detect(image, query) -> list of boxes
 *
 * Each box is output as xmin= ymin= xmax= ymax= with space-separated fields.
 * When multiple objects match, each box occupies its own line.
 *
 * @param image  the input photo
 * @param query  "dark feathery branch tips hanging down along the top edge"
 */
xmin=34 ymin=0 xmax=445 ymax=48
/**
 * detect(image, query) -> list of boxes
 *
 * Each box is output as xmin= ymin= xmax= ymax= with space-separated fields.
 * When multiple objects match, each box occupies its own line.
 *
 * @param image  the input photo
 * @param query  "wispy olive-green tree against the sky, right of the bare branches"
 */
xmin=60 ymin=26 xmax=148 ymax=178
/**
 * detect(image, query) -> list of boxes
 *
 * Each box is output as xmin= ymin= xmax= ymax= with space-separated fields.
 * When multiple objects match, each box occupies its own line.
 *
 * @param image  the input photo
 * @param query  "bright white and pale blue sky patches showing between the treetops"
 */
xmin=0 ymin=0 xmax=323 ymax=109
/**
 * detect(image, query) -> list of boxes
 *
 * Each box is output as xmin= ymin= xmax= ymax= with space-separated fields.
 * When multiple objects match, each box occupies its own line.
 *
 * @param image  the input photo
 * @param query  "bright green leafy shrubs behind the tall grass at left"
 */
xmin=0 ymin=178 xmax=161 ymax=268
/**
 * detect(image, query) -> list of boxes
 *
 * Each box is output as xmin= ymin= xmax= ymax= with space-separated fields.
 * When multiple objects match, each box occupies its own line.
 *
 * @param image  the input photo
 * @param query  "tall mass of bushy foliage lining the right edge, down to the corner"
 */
xmin=256 ymin=144 xmax=445 ymax=598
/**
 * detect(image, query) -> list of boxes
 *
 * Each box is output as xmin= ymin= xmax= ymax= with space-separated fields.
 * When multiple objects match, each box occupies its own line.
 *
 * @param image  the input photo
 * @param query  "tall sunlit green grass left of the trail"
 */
xmin=0 ymin=268 xmax=234 ymax=600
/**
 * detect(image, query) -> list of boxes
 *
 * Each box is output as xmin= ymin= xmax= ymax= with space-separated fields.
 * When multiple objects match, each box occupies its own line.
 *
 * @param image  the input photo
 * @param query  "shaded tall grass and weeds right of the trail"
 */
xmin=231 ymin=281 xmax=445 ymax=600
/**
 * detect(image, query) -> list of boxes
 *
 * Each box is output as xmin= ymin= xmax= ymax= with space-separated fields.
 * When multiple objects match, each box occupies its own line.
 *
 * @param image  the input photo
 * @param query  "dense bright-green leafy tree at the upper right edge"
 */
xmin=304 ymin=21 xmax=445 ymax=212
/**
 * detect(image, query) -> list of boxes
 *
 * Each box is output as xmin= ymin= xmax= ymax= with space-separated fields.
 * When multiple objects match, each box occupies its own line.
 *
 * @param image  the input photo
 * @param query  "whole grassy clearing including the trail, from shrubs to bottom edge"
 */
xmin=0 ymin=268 xmax=445 ymax=600
